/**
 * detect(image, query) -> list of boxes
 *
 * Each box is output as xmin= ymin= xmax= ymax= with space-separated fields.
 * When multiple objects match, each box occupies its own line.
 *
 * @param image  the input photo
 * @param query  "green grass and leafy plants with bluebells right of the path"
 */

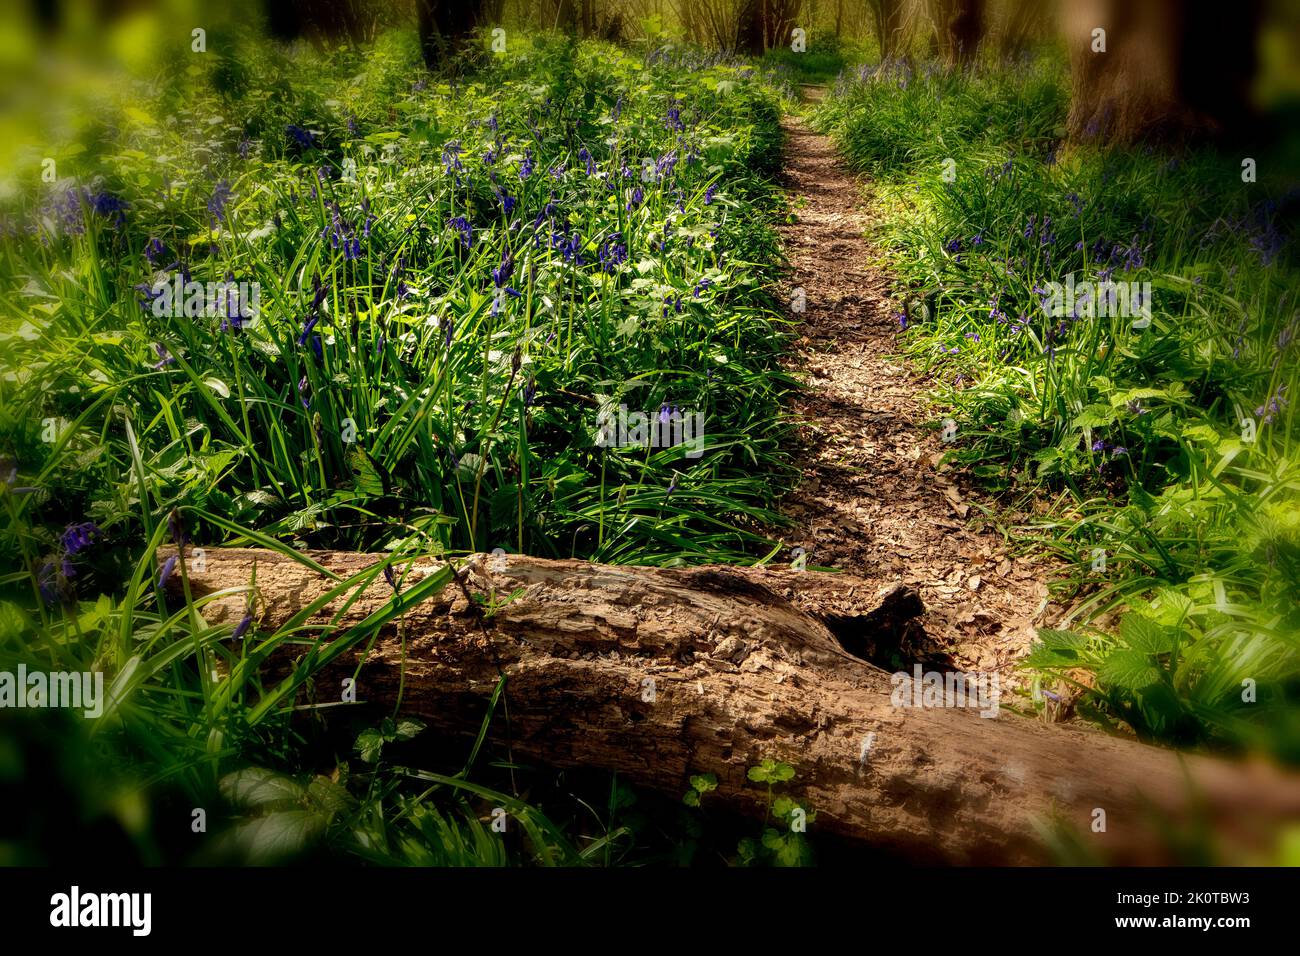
xmin=818 ymin=60 xmax=1300 ymax=761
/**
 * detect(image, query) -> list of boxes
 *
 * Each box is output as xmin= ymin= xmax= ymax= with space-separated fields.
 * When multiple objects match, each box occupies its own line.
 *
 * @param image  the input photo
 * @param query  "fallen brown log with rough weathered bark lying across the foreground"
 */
xmin=173 ymin=549 xmax=1300 ymax=864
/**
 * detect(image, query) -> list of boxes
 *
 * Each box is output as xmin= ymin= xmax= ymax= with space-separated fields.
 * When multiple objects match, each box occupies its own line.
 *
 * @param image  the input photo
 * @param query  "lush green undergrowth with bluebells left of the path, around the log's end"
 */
xmin=0 ymin=31 xmax=794 ymax=865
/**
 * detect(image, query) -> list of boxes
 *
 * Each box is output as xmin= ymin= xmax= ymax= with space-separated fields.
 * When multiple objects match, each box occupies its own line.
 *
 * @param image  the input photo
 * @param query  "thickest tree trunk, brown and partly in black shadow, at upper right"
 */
xmin=1062 ymin=0 xmax=1261 ymax=144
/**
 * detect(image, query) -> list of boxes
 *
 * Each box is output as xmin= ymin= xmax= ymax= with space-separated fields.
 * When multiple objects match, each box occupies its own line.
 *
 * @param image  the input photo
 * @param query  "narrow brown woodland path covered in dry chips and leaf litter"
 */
xmin=781 ymin=90 xmax=1049 ymax=683
